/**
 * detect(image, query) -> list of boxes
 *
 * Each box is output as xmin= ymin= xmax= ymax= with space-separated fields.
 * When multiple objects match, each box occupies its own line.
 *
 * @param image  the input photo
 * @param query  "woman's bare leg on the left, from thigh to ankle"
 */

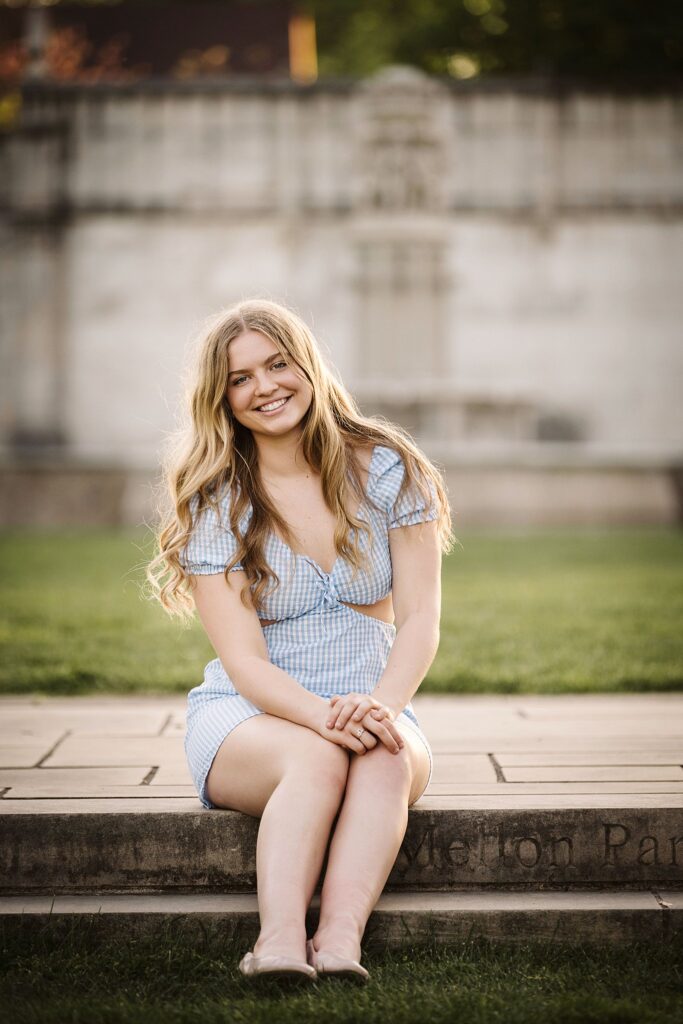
xmin=207 ymin=714 xmax=349 ymax=961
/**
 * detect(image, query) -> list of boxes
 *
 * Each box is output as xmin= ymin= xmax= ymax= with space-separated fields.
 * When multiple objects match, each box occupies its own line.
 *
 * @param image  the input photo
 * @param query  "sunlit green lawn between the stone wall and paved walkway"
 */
xmin=0 ymin=528 xmax=683 ymax=694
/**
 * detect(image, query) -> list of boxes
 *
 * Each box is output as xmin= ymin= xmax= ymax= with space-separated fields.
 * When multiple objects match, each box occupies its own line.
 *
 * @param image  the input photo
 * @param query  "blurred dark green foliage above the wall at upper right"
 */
xmin=307 ymin=0 xmax=683 ymax=82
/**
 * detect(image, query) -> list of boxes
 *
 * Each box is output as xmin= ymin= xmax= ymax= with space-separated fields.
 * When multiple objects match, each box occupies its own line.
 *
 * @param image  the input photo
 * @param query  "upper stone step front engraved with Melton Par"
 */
xmin=0 ymin=796 xmax=683 ymax=895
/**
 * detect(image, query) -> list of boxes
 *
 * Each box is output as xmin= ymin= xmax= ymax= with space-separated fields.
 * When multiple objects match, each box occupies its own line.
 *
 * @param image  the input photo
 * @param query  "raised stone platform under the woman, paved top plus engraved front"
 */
xmin=0 ymin=694 xmax=683 ymax=892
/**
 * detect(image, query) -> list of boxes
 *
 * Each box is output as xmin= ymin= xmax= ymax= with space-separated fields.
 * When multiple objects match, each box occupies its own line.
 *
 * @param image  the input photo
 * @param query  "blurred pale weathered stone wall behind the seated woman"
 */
xmin=0 ymin=68 xmax=683 ymax=521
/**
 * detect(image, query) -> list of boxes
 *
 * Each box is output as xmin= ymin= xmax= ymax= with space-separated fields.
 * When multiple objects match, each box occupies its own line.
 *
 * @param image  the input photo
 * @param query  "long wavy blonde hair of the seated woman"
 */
xmin=146 ymin=299 xmax=456 ymax=618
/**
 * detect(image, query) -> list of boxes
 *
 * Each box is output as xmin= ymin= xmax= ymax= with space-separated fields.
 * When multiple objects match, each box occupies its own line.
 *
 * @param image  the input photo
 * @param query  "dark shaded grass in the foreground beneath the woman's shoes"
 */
xmin=0 ymin=928 xmax=683 ymax=1024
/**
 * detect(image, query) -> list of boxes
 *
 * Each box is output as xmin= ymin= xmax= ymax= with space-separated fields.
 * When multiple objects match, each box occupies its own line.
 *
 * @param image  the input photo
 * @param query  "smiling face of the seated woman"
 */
xmin=226 ymin=331 xmax=313 ymax=437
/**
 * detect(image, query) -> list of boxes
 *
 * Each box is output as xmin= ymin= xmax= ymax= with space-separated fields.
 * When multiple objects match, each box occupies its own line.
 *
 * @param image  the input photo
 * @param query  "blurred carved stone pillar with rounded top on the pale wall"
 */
xmin=350 ymin=67 xmax=452 ymax=436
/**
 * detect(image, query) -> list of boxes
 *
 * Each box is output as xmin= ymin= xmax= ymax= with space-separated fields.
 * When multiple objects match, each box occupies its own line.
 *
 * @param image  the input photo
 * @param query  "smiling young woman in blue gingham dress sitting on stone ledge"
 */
xmin=148 ymin=300 xmax=454 ymax=980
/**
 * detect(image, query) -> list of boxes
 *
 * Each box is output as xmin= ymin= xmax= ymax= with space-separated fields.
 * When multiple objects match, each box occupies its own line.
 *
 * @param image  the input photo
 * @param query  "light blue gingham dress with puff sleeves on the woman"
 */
xmin=180 ymin=444 xmax=437 ymax=808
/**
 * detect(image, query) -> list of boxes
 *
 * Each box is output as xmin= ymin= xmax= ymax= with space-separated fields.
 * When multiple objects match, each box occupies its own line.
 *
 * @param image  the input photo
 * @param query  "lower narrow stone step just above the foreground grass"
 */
xmin=0 ymin=890 xmax=683 ymax=952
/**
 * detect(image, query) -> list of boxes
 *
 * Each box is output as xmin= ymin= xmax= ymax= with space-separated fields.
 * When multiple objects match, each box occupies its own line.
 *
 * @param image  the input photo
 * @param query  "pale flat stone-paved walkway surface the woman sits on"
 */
xmin=0 ymin=694 xmax=683 ymax=814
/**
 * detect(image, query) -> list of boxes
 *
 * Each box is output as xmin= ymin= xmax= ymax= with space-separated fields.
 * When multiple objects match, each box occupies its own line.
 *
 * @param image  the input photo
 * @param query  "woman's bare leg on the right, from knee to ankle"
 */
xmin=313 ymin=728 xmax=429 ymax=959
